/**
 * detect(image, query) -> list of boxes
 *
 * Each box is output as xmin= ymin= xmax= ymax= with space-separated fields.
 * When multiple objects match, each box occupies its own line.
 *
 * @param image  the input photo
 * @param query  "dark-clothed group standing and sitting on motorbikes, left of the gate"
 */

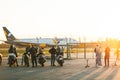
xmin=8 ymin=45 xmax=64 ymax=67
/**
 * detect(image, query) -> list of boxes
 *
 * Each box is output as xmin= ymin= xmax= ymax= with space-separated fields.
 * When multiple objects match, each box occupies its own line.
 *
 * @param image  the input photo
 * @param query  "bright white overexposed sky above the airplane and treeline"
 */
xmin=0 ymin=0 xmax=120 ymax=41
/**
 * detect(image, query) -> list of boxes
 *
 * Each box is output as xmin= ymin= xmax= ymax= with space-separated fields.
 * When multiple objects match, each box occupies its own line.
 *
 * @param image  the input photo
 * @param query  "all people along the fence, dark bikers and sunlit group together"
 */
xmin=8 ymin=45 xmax=118 ymax=67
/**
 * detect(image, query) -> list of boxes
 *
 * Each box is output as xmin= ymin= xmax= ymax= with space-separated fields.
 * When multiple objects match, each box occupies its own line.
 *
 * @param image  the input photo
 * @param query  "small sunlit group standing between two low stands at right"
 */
xmin=94 ymin=45 xmax=110 ymax=67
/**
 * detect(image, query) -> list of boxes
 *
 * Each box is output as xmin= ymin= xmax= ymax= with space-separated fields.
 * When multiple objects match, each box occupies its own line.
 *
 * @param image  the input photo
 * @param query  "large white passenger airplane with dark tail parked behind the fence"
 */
xmin=2 ymin=27 xmax=77 ymax=48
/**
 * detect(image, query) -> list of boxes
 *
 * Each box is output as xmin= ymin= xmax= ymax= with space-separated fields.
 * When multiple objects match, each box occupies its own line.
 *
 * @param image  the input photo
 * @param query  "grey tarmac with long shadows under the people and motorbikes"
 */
xmin=0 ymin=58 xmax=120 ymax=80
